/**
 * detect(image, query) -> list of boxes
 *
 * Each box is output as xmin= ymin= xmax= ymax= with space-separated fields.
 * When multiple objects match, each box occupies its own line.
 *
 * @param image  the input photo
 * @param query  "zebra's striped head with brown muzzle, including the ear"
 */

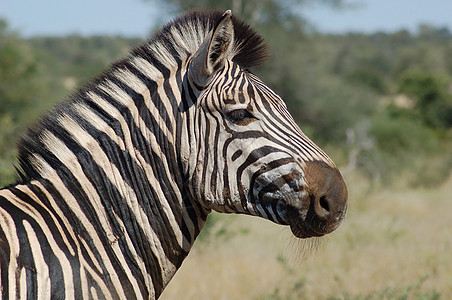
xmin=185 ymin=11 xmax=347 ymax=238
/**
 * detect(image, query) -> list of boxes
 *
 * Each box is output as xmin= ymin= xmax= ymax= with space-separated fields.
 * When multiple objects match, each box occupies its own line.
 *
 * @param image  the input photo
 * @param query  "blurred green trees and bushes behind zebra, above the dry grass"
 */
xmin=0 ymin=7 xmax=452 ymax=186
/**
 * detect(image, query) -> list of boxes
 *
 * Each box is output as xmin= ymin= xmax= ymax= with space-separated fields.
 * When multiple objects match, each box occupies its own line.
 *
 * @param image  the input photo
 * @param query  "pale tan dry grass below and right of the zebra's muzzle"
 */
xmin=162 ymin=178 xmax=452 ymax=299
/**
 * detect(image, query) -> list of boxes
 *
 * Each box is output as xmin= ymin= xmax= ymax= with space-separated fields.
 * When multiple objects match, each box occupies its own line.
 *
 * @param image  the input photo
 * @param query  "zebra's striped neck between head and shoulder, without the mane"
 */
xmin=14 ymin=61 xmax=207 ymax=296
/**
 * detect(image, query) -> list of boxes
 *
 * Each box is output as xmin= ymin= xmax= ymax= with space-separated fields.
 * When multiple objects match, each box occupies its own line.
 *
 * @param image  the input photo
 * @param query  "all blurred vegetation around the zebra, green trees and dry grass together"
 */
xmin=0 ymin=0 xmax=452 ymax=299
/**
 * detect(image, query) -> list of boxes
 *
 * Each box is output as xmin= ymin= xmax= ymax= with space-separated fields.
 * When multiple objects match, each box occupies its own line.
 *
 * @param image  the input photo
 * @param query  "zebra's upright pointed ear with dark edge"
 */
xmin=188 ymin=10 xmax=234 ymax=88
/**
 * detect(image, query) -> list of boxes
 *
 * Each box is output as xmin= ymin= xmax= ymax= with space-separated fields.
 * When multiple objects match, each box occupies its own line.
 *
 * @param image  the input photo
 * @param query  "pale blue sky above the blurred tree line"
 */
xmin=0 ymin=0 xmax=452 ymax=37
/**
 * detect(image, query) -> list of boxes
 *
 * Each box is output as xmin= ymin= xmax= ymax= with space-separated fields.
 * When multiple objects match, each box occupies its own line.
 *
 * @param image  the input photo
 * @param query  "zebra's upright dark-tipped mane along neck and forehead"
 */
xmin=16 ymin=11 xmax=268 ymax=182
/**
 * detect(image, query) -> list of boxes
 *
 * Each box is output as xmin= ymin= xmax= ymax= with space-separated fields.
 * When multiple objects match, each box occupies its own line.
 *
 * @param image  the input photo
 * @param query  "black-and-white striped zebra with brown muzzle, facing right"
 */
xmin=0 ymin=10 xmax=347 ymax=299
